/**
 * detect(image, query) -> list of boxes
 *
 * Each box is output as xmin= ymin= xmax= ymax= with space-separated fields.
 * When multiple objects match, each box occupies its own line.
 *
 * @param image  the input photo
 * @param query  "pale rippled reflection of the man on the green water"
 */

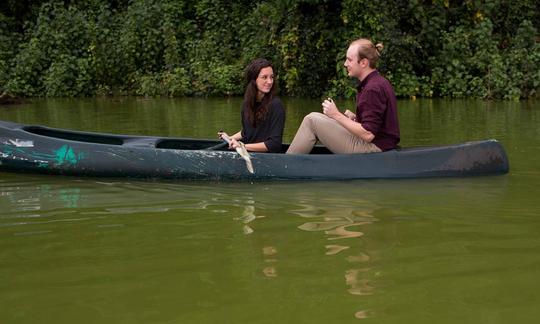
xmin=293 ymin=199 xmax=380 ymax=319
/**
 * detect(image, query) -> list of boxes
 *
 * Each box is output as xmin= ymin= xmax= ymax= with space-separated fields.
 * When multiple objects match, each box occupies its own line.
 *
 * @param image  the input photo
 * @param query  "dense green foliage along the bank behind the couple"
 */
xmin=0 ymin=0 xmax=540 ymax=99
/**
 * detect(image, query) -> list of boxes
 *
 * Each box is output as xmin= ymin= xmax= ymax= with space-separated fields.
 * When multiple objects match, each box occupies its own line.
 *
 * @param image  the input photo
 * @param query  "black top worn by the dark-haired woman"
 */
xmin=242 ymin=97 xmax=285 ymax=153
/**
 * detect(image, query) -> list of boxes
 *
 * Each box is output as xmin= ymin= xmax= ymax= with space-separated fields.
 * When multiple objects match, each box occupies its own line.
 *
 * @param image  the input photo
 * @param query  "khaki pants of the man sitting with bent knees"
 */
xmin=287 ymin=112 xmax=381 ymax=154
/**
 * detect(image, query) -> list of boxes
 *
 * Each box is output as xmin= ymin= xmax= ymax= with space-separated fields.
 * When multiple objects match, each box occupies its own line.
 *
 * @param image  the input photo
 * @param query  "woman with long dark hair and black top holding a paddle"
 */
xmin=218 ymin=58 xmax=285 ymax=153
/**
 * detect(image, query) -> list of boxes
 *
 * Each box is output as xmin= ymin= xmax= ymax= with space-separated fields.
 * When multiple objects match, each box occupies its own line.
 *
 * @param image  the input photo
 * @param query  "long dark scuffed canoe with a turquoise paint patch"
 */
xmin=0 ymin=121 xmax=508 ymax=180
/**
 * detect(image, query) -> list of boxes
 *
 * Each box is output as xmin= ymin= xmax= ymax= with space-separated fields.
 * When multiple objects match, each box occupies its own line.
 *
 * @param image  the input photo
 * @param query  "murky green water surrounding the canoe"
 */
xmin=0 ymin=98 xmax=540 ymax=323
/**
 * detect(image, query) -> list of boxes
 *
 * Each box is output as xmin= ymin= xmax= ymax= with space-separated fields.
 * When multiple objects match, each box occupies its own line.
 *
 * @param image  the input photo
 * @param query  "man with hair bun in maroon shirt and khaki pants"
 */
xmin=287 ymin=39 xmax=399 ymax=154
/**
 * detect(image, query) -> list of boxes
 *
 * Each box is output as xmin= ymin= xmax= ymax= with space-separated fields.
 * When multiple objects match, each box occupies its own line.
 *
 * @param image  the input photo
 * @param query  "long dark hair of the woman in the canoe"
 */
xmin=244 ymin=58 xmax=277 ymax=127
